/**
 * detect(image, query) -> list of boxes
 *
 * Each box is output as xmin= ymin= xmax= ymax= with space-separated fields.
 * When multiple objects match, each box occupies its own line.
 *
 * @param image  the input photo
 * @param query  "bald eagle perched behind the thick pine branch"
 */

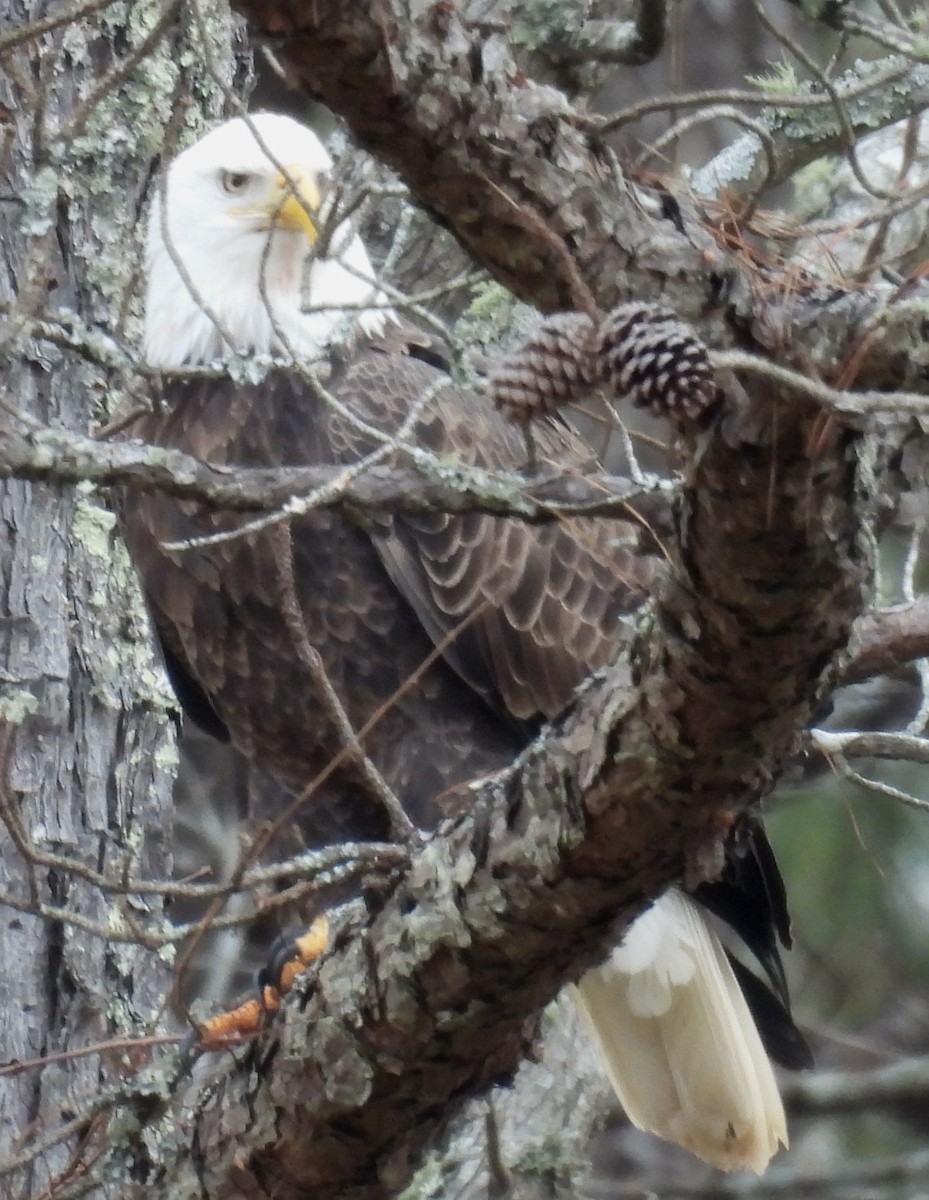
xmin=122 ymin=114 xmax=808 ymax=1172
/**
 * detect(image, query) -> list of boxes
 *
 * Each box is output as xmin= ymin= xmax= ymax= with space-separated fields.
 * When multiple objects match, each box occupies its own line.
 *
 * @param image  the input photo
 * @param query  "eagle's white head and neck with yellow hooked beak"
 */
xmin=144 ymin=113 xmax=384 ymax=368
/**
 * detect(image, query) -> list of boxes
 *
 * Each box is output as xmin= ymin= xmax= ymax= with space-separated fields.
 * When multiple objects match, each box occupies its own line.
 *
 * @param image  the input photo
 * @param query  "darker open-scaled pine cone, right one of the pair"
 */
xmin=594 ymin=304 xmax=720 ymax=424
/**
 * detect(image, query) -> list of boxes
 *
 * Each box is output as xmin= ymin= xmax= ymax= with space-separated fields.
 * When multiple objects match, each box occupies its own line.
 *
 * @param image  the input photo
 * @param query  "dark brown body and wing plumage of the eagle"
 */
xmin=125 ymin=330 xmax=659 ymax=836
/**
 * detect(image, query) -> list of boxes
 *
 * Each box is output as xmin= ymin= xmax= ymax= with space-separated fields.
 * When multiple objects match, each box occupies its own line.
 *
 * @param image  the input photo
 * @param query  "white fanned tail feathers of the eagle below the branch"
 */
xmin=576 ymin=890 xmax=787 ymax=1175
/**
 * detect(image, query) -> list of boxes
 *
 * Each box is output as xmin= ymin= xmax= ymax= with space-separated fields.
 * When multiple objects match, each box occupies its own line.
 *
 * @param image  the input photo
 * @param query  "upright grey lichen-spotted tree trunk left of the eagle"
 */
xmin=0 ymin=2 xmax=230 ymax=1196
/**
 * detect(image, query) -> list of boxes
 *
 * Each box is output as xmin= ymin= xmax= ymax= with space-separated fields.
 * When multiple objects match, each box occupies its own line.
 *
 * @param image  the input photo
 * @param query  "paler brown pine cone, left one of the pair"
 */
xmin=487 ymin=312 xmax=599 ymax=422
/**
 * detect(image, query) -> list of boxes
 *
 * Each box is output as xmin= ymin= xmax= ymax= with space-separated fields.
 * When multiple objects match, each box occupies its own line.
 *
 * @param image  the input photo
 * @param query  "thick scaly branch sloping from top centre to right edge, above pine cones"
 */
xmin=230 ymin=0 xmax=929 ymax=394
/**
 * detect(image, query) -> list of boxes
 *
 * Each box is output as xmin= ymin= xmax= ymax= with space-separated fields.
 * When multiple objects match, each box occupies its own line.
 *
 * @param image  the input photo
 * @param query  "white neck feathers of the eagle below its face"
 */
xmin=144 ymin=204 xmax=389 ymax=370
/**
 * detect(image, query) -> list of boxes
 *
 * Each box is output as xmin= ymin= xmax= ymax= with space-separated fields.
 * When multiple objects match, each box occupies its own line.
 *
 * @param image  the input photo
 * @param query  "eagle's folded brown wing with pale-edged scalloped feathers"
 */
xmin=326 ymin=342 xmax=660 ymax=726
